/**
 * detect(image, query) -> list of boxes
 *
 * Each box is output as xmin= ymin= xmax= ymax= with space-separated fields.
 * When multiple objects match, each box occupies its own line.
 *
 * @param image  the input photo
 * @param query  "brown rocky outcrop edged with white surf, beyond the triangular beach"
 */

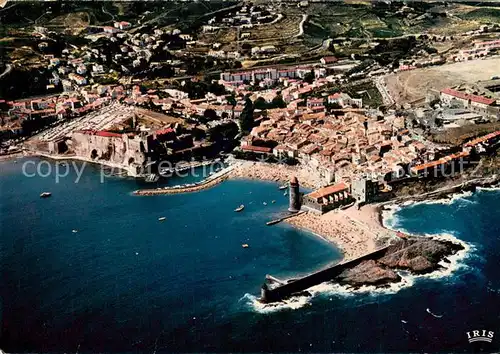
xmin=333 ymin=237 xmax=463 ymax=287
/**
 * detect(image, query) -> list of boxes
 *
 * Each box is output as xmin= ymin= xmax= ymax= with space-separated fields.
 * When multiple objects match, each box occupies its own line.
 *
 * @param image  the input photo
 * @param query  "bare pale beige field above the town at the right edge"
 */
xmin=385 ymin=58 xmax=500 ymax=104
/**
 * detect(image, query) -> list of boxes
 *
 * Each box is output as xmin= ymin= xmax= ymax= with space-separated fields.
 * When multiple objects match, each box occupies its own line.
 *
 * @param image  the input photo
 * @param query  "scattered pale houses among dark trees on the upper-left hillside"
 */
xmin=36 ymin=21 xmax=203 ymax=93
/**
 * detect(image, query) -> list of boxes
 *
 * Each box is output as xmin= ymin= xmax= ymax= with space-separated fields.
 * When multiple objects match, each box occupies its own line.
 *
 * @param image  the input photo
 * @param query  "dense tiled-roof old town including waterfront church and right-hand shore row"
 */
xmin=240 ymin=101 xmax=500 ymax=213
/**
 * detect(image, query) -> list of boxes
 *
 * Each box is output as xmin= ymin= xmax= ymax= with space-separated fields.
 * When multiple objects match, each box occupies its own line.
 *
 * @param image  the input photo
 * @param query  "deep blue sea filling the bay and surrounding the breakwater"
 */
xmin=0 ymin=158 xmax=500 ymax=353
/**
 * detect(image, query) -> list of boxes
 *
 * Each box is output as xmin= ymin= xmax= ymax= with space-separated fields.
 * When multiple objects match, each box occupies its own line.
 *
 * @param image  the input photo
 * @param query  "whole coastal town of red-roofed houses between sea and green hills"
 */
xmin=1 ymin=2 xmax=500 ymax=205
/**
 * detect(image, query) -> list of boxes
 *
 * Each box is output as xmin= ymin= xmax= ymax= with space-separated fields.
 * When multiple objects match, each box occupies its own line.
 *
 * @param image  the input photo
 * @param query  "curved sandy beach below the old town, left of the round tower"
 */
xmin=230 ymin=161 xmax=322 ymax=189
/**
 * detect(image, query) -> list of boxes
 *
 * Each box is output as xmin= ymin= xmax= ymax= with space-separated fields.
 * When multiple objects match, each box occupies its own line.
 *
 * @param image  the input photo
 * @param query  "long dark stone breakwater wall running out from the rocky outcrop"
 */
xmin=260 ymin=246 xmax=389 ymax=303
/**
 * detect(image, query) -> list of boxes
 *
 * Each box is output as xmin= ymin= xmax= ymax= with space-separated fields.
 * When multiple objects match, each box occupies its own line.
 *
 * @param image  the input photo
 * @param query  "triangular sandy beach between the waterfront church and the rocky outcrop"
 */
xmin=287 ymin=205 xmax=391 ymax=261
